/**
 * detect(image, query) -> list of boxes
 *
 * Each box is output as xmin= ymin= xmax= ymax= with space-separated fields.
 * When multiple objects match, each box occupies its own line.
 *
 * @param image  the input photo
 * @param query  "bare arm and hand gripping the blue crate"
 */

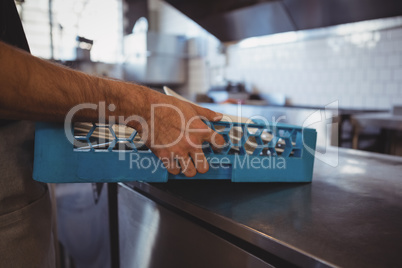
xmin=0 ymin=42 xmax=224 ymax=176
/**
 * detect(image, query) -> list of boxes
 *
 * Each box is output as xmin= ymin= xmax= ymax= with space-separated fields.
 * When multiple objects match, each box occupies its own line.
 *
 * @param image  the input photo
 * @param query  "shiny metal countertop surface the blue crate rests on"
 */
xmin=128 ymin=148 xmax=402 ymax=267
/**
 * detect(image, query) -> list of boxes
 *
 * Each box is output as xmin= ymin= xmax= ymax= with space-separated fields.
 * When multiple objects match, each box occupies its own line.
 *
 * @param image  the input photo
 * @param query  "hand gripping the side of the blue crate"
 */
xmin=139 ymin=92 xmax=225 ymax=177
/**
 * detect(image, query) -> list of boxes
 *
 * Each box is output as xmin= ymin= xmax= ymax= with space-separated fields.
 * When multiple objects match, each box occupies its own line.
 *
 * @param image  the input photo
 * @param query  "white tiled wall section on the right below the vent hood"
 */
xmin=223 ymin=24 xmax=402 ymax=109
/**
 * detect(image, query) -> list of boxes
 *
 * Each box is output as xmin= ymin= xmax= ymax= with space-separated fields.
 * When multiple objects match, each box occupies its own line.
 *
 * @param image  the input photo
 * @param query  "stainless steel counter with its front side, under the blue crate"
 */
xmin=118 ymin=147 xmax=402 ymax=267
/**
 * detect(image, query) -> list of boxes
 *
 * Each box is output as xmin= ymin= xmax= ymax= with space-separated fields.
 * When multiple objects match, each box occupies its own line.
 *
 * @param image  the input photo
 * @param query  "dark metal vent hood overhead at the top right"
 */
xmin=165 ymin=0 xmax=402 ymax=42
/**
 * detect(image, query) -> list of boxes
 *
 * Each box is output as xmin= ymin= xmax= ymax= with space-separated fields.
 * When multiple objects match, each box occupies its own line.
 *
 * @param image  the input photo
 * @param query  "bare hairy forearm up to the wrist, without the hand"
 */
xmin=0 ymin=42 xmax=152 ymax=129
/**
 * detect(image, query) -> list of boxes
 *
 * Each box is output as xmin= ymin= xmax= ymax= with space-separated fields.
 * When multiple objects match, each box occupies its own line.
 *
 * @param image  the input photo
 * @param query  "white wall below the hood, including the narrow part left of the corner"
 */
xmin=155 ymin=0 xmax=402 ymax=109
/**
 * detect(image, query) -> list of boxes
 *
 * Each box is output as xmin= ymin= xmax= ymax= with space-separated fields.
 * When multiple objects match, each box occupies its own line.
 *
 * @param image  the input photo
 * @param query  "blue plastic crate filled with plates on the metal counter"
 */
xmin=33 ymin=121 xmax=317 ymax=183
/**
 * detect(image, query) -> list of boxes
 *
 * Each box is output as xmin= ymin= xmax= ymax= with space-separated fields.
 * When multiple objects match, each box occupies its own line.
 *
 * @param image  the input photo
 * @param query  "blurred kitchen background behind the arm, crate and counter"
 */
xmin=16 ymin=0 xmax=402 ymax=155
